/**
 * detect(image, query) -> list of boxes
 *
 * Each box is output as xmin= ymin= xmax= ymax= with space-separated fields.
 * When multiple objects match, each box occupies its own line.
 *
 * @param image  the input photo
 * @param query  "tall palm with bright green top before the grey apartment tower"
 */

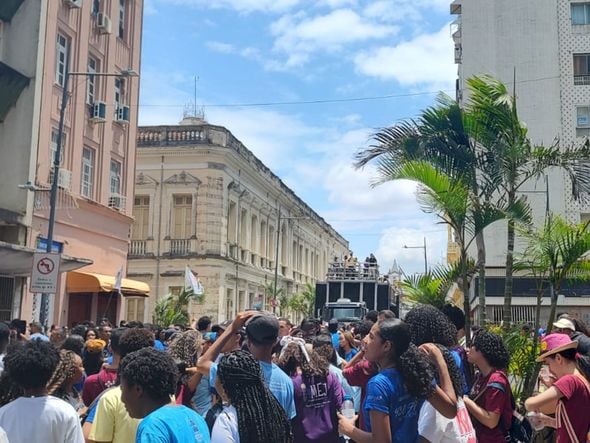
xmin=467 ymin=76 xmax=590 ymax=326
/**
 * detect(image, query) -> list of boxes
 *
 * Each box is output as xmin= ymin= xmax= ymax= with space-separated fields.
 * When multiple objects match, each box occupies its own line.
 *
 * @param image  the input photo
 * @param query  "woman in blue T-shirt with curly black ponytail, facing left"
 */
xmin=339 ymin=319 xmax=457 ymax=443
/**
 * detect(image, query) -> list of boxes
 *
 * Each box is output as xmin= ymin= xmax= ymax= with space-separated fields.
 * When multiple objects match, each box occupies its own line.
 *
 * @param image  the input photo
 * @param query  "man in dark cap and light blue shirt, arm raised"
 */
xmin=197 ymin=311 xmax=296 ymax=419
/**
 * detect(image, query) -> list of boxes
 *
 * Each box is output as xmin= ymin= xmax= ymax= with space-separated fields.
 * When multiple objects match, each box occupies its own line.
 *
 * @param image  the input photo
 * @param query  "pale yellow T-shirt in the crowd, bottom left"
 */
xmin=88 ymin=386 xmax=141 ymax=443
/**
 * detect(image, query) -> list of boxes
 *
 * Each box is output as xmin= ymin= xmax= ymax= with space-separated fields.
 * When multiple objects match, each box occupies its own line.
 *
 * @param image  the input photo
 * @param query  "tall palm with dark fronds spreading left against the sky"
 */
xmin=355 ymin=94 xmax=488 ymax=324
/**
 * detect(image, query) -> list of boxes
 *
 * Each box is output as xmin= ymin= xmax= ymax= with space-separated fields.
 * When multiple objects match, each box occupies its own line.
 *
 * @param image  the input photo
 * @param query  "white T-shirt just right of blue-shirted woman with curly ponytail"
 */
xmin=418 ymin=398 xmax=477 ymax=443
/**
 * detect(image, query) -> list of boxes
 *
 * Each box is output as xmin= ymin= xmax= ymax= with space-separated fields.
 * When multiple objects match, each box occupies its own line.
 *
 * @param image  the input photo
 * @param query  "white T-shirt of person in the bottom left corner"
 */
xmin=0 ymin=395 xmax=84 ymax=443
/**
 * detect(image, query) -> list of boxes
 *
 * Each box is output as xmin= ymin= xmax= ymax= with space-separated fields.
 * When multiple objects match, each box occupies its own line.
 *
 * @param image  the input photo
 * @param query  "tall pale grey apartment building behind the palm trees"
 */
xmin=448 ymin=0 xmax=590 ymax=322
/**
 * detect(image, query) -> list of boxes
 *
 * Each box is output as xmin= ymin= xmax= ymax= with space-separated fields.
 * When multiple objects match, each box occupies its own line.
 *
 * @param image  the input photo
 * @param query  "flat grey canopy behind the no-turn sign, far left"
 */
xmin=0 ymin=241 xmax=92 ymax=277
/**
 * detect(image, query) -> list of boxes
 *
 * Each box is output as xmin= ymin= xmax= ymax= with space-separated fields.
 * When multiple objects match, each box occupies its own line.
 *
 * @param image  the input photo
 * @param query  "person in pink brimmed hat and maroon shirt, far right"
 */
xmin=524 ymin=332 xmax=590 ymax=443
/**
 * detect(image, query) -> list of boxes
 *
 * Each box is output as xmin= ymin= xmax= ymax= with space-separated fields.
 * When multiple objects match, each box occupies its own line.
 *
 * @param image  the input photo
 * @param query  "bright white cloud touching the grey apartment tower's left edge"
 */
xmin=354 ymin=25 xmax=457 ymax=89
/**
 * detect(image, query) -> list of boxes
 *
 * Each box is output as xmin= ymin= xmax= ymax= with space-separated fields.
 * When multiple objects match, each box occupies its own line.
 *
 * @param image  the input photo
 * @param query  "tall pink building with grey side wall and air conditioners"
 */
xmin=0 ymin=0 xmax=149 ymax=324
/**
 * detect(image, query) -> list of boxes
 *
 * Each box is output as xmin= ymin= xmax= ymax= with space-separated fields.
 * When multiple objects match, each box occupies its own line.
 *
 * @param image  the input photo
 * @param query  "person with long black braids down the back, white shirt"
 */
xmin=211 ymin=350 xmax=293 ymax=443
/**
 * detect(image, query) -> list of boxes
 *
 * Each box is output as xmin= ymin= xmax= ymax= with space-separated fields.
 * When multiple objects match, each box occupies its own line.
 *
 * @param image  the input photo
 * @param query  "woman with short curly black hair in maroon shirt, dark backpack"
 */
xmin=464 ymin=329 xmax=512 ymax=443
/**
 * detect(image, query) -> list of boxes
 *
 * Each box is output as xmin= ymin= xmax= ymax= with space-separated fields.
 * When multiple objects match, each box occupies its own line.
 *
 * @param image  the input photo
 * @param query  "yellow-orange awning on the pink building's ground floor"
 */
xmin=66 ymin=272 xmax=150 ymax=297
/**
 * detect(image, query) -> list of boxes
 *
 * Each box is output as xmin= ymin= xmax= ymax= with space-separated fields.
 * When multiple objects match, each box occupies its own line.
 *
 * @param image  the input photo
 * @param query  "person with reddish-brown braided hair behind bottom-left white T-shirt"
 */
xmin=47 ymin=349 xmax=84 ymax=411
